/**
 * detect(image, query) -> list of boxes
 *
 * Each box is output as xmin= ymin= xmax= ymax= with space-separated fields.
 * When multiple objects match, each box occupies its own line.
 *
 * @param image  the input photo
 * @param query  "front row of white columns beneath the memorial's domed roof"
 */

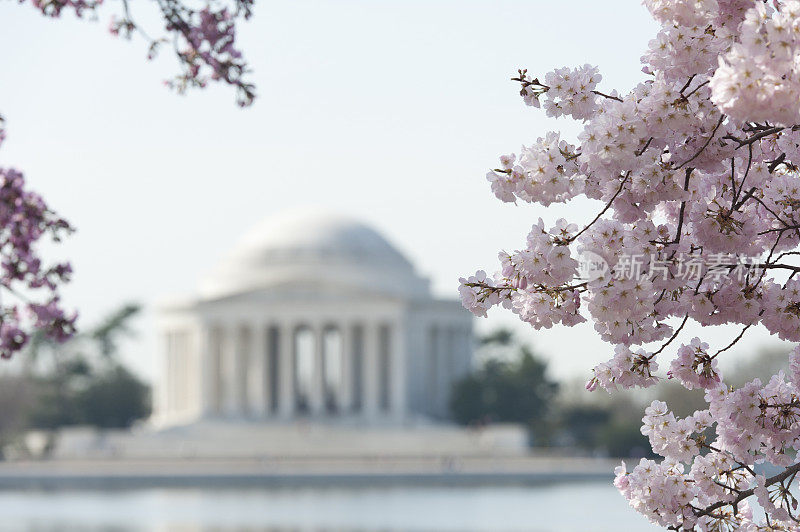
xmin=161 ymin=320 xmax=407 ymax=419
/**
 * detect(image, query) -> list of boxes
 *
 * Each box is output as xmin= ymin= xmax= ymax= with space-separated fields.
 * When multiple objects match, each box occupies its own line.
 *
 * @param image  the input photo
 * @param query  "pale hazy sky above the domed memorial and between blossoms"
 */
xmin=0 ymin=0 xmax=788 ymax=382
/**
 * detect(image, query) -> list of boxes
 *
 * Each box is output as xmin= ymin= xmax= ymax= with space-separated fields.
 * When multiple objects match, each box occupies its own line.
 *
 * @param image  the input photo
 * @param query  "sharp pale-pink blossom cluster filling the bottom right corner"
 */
xmin=615 ymin=350 xmax=800 ymax=531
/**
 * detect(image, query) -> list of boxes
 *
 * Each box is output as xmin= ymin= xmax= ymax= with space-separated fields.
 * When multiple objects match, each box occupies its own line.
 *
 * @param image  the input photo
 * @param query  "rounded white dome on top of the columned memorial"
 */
xmin=201 ymin=211 xmax=428 ymax=298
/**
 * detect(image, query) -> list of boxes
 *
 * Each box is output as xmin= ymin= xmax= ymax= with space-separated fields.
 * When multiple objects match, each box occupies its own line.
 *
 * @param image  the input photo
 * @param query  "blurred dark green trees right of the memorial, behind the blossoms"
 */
xmin=450 ymin=329 xmax=744 ymax=458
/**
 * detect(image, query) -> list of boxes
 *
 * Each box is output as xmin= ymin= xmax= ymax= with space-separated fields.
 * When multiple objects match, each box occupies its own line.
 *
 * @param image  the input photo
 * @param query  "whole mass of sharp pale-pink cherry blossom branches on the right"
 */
xmin=460 ymin=0 xmax=800 ymax=530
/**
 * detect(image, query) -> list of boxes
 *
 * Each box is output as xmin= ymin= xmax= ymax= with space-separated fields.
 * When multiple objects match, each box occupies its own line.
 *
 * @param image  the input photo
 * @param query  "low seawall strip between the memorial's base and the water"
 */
xmin=0 ymin=457 xmax=619 ymax=490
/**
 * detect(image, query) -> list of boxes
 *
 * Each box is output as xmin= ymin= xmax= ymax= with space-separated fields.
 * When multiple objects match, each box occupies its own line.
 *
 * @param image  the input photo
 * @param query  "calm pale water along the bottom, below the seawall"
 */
xmin=0 ymin=481 xmax=658 ymax=532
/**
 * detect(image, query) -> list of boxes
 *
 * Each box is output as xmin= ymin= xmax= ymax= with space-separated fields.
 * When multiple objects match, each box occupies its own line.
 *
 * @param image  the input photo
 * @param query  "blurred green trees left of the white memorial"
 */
xmin=0 ymin=304 xmax=150 ymax=458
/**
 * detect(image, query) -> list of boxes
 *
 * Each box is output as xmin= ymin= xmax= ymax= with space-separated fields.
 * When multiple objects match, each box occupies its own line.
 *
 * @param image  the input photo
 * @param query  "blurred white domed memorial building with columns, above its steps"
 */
xmin=153 ymin=213 xmax=472 ymax=426
